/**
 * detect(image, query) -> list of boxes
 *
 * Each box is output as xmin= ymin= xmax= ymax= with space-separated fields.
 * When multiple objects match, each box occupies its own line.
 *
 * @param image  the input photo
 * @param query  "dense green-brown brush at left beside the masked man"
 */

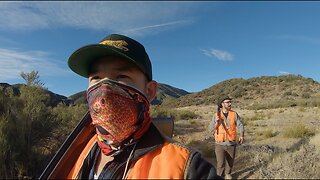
xmin=0 ymin=73 xmax=88 ymax=179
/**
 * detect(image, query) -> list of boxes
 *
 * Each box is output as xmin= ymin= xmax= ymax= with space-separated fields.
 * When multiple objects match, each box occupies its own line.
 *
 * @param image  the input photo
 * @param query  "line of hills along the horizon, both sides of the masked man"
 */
xmin=0 ymin=75 xmax=320 ymax=109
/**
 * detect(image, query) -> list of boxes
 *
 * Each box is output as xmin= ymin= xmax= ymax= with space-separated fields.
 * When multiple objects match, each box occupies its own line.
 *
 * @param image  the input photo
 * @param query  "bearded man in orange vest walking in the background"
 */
xmin=210 ymin=96 xmax=244 ymax=179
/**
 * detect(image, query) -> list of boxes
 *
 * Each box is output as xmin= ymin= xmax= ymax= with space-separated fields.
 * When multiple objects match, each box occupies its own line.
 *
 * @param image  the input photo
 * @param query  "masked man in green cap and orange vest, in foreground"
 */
xmin=47 ymin=34 xmax=220 ymax=179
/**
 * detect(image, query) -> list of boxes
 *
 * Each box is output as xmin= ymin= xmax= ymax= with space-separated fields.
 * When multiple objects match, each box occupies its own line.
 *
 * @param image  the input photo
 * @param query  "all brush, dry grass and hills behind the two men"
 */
xmin=0 ymin=72 xmax=320 ymax=179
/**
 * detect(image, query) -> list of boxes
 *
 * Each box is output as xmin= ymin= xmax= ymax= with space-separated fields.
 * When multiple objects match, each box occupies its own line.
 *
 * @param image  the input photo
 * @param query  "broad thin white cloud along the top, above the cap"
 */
xmin=0 ymin=1 xmax=197 ymax=33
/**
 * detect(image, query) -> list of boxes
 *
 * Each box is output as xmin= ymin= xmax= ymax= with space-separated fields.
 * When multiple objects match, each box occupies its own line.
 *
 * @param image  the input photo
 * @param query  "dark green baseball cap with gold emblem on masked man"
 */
xmin=68 ymin=34 xmax=152 ymax=81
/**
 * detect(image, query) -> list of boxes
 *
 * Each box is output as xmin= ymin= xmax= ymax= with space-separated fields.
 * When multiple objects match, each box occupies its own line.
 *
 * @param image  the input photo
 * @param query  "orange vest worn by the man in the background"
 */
xmin=214 ymin=111 xmax=237 ymax=142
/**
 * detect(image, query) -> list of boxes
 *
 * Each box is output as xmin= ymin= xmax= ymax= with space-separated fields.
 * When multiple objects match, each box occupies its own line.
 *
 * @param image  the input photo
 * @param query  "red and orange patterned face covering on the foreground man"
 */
xmin=87 ymin=79 xmax=151 ymax=156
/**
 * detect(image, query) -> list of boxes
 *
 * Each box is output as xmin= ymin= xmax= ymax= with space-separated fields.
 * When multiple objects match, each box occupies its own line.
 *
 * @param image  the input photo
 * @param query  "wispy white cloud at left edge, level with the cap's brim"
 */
xmin=0 ymin=48 xmax=68 ymax=82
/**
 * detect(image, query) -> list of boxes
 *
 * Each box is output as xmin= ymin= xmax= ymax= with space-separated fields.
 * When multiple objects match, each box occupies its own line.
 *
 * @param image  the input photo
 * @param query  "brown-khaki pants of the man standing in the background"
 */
xmin=215 ymin=144 xmax=236 ymax=176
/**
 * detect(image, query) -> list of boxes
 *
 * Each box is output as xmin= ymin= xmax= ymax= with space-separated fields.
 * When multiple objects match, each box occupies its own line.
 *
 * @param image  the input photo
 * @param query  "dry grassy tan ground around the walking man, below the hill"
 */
xmin=173 ymin=106 xmax=320 ymax=179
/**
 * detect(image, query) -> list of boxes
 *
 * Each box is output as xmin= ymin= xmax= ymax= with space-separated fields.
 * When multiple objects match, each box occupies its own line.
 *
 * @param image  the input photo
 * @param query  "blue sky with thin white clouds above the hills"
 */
xmin=0 ymin=1 xmax=320 ymax=96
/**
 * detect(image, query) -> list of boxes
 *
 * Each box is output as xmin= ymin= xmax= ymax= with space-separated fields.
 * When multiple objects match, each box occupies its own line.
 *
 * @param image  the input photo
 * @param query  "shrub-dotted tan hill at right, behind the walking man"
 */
xmin=163 ymin=75 xmax=320 ymax=109
